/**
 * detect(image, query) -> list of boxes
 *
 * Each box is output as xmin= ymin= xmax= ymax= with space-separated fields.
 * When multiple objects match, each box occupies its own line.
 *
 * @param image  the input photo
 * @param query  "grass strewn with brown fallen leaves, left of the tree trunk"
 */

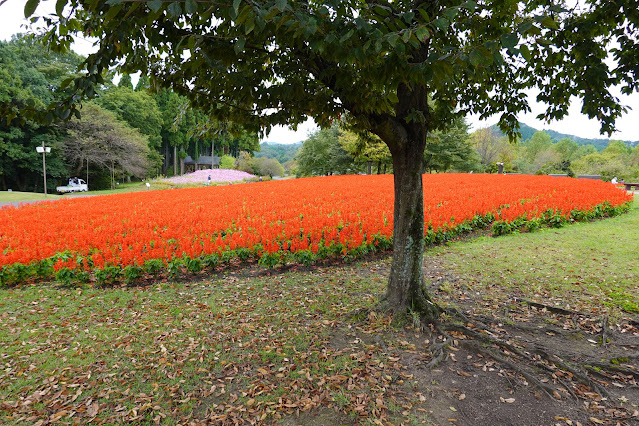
xmin=0 ymin=266 xmax=440 ymax=424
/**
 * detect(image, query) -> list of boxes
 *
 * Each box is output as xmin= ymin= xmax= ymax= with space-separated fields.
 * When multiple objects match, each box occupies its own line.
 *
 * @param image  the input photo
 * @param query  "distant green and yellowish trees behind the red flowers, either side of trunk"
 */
xmin=292 ymin=119 xmax=639 ymax=181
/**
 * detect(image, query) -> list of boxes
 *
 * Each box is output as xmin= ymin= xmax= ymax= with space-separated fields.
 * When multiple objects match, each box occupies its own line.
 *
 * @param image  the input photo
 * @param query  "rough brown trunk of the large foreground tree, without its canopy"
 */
xmin=386 ymin=136 xmax=440 ymax=322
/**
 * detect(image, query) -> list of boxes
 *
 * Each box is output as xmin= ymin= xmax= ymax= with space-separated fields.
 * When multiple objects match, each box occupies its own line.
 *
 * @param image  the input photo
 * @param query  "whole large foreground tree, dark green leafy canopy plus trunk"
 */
xmin=18 ymin=0 xmax=639 ymax=321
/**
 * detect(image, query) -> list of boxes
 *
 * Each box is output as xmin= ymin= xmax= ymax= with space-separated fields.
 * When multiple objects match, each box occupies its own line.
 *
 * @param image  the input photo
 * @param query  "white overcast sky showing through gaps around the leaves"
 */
xmin=0 ymin=0 xmax=639 ymax=143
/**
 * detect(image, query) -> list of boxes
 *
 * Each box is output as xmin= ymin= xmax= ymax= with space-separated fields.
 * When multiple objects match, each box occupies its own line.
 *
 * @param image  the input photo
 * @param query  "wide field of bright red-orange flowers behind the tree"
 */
xmin=0 ymin=174 xmax=632 ymax=281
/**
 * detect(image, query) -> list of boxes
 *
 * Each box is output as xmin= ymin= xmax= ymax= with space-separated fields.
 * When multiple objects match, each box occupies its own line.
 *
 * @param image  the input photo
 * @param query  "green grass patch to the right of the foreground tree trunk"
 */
xmin=437 ymin=196 xmax=639 ymax=317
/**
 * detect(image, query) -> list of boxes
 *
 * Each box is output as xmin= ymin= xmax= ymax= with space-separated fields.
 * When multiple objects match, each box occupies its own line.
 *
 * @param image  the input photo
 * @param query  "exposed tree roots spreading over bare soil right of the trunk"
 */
xmin=420 ymin=301 xmax=639 ymax=419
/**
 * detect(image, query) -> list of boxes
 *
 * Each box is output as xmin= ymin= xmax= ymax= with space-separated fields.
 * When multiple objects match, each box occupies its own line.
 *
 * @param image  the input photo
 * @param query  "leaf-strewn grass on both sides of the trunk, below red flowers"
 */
xmin=0 ymin=196 xmax=639 ymax=424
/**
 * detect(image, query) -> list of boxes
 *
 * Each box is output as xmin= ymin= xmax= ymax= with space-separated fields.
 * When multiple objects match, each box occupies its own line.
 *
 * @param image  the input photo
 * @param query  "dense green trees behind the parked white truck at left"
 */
xmin=0 ymin=35 xmax=259 ymax=192
